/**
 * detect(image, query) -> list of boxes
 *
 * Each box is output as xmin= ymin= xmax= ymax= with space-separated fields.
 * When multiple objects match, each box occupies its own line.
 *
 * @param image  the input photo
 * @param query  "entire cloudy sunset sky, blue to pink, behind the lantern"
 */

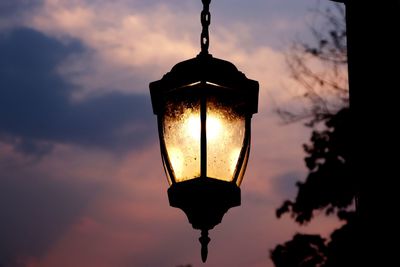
xmin=0 ymin=0 xmax=337 ymax=267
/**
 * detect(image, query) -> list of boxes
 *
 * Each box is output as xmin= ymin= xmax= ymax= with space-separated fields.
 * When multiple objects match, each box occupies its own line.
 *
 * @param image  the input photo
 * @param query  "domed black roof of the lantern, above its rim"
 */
xmin=150 ymin=53 xmax=259 ymax=92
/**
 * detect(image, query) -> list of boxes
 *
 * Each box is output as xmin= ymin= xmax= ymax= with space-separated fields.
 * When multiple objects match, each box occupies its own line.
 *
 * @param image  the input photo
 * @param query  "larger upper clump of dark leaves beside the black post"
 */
xmin=276 ymin=108 xmax=357 ymax=224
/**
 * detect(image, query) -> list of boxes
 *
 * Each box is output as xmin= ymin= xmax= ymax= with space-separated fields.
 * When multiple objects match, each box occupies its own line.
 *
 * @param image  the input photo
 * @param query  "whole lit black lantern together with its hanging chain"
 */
xmin=150 ymin=0 xmax=259 ymax=262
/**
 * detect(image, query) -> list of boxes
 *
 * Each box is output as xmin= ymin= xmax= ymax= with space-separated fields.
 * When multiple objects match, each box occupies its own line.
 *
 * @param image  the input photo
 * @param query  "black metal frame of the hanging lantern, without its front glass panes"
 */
xmin=150 ymin=52 xmax=259 ymax=261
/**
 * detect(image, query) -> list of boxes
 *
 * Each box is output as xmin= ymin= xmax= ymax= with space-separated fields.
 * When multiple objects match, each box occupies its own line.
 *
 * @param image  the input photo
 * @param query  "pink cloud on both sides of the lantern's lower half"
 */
xmin=3 ymin=136 xmax=338 ymax=267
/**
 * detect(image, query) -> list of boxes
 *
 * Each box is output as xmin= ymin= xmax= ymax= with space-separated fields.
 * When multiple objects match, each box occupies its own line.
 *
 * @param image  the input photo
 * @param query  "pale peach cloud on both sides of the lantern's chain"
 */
xmin=16 ymin=0 xmax=301 ymax=111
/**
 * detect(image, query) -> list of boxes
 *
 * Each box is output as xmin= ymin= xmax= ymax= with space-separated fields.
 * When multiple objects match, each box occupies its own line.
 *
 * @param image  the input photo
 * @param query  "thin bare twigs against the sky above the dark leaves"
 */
xmin=277 ymin=4 xmax=349 ymax=127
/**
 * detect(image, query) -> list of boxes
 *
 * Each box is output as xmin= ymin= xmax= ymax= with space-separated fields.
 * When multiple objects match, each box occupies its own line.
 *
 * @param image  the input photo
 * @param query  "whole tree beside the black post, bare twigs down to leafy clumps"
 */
xmin=270 ymin=5 xmax=357 ymax=267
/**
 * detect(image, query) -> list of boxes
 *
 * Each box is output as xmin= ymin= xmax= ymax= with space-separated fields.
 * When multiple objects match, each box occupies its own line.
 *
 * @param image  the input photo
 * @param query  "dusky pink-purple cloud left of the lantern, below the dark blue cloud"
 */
xmin=0 ymin=144 xmax=198 ymax=267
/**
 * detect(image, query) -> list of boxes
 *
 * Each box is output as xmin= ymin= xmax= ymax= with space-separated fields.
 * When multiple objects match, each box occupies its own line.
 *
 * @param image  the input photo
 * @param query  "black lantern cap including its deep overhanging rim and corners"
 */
xmin=150 ymin=53 xmax=259 ymax=114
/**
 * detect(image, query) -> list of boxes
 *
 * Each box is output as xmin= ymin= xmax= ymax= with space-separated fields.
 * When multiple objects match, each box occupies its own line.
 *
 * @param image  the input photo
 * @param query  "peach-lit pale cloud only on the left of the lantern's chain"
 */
xmin=29 ymin=0 xmax=199 ymax=98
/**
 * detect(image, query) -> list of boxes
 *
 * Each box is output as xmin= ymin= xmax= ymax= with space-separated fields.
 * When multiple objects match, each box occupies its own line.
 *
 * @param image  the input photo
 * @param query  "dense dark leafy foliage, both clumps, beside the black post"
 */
xmin=271 ymin=108 xmax=357 ymax=267
